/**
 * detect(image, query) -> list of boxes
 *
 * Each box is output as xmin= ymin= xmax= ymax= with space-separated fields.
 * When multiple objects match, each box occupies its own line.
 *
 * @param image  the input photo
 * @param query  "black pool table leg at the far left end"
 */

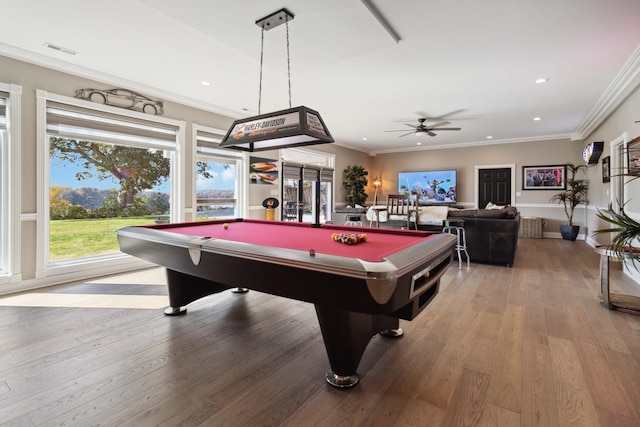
xmin=164 ymin=268 xmax=235 ymax=316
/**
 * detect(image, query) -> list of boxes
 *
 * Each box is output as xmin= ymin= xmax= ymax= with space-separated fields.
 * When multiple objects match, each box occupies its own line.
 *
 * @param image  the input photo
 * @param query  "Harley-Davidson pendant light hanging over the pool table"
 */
xmin=220 ymin=9 xmax=334 ymax=152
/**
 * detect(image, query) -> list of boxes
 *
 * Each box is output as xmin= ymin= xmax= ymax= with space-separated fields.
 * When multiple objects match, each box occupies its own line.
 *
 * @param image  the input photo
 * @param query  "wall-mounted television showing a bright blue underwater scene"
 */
xmin=398 ymin=169 xmax=457 ymax=205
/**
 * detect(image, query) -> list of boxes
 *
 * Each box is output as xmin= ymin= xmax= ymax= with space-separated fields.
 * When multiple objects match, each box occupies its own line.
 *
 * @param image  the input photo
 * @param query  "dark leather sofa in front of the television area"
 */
xmin=418 ymin=206 xmax=520 ymax=267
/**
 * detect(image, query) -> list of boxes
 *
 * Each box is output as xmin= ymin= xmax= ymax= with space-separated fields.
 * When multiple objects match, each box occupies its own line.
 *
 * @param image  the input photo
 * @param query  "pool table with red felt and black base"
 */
xmin=117 ymin=219 xmax=456 ymax=388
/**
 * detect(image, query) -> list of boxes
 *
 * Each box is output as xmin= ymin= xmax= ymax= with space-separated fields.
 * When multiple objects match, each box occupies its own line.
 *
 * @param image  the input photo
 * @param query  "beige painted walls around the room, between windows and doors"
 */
xmin=0 ymin=51 xmax=640 ymax=290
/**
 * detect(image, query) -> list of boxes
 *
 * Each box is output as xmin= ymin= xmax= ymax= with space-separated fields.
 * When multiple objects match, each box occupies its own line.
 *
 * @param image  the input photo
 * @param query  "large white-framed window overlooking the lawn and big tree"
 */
xmin=38 ymin=91 xmax=183 ymax=265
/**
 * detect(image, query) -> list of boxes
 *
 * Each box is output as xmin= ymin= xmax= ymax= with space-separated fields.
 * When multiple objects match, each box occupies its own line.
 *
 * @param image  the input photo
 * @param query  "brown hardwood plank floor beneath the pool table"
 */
xmin=0 ymin=239 xmax=640 ymax=427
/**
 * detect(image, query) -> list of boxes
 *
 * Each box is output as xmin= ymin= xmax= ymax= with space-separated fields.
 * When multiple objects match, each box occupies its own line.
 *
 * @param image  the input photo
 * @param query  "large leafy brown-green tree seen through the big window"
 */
xmin=49 ymin=137 xmax=170 ymax=207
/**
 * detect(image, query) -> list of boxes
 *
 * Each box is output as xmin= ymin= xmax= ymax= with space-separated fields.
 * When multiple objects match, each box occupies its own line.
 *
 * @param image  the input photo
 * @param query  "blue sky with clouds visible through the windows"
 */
xmin=49 ymin=159 xmax=235 ymax=193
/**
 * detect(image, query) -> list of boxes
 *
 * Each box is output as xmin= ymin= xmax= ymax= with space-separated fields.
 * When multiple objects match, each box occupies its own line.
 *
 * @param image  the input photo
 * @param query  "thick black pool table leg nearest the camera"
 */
xmin=315 ymin=304 xmax=401 ymax=388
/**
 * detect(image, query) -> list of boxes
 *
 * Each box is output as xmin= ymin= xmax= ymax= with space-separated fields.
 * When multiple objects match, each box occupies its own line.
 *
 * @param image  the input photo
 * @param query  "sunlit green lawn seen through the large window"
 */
xmin=49 ymin=217 xmax=156 ymax=261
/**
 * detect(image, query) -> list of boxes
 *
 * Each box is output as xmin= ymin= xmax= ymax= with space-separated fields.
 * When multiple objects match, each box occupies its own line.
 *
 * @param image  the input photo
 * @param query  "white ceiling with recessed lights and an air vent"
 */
xmin=0 ymin=0 xmax=640 ymax=154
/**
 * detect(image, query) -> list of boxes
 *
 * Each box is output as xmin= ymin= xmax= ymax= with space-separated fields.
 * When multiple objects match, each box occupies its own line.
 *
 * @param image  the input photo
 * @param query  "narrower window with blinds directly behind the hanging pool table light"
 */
xmin=193 ymin=125 xmax=244 ymax=220
